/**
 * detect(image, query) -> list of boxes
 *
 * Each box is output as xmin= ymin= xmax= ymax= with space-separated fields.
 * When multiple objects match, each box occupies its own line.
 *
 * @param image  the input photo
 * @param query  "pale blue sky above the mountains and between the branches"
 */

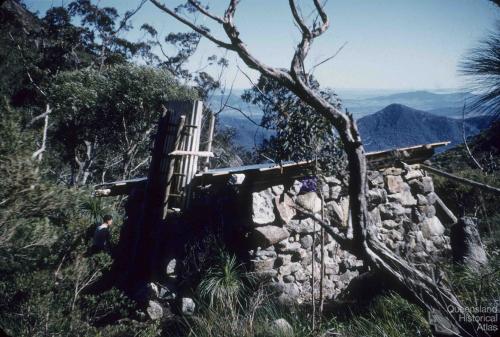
xmin=25 ymin=0 xmax=500 ymax=91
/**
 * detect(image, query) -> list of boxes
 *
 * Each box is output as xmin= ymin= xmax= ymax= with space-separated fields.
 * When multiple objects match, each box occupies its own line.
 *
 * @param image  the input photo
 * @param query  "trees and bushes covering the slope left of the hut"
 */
xmin=0 ymin=0 xmax=237 ymax=336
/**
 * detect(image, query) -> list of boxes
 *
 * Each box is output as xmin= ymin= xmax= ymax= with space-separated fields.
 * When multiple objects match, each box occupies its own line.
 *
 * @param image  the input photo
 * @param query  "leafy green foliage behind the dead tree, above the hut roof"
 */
xmin=242 ymin=76 xmax=342 ymax=169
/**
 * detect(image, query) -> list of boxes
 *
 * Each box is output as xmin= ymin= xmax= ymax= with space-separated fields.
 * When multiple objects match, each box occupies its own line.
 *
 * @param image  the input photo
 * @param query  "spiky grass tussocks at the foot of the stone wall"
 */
xmin=182 ymin=249 xmax=431 ymax=337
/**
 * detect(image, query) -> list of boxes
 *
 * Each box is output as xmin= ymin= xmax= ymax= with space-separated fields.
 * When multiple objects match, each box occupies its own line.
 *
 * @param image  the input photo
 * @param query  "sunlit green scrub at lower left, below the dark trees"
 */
xmin=0 ymin=100 xmax=157 ymax=337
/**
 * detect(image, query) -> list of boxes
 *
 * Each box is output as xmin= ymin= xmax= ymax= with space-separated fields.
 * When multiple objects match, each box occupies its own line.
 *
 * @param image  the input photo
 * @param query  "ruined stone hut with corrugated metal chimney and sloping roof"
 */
xmin=96 ymin=102 xmax=456 ymax=302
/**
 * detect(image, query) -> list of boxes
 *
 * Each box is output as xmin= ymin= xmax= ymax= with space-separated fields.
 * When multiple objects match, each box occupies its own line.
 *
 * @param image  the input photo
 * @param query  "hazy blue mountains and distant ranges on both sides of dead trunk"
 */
xmin=211 ymin=91 xmax=491 ymax=151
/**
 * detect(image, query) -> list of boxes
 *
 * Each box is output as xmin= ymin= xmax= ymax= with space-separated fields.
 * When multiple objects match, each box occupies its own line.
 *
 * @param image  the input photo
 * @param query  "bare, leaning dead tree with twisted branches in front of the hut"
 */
xmin=150 ymin=0 xmax=477 ymax=336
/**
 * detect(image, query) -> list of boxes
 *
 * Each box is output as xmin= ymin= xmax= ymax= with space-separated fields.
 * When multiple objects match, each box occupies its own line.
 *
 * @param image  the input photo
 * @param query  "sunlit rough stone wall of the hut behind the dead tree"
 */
xmin=236 ymin=165 xmax=454 ymax=302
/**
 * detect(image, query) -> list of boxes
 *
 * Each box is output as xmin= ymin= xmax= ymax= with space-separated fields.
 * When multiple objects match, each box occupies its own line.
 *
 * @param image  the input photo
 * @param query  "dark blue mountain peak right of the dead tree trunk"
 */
xmin=358 ymin=104 xmax=492 ymax=151
